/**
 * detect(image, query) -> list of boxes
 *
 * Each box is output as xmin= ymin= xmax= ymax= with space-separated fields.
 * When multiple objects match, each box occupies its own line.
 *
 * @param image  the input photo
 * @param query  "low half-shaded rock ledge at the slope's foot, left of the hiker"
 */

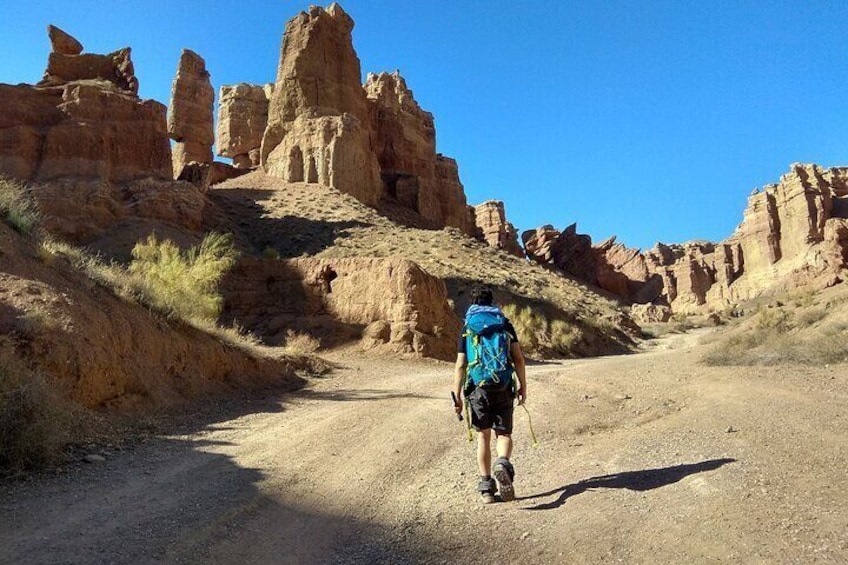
xmin=222 ymin=258 xmax=460 ymax=360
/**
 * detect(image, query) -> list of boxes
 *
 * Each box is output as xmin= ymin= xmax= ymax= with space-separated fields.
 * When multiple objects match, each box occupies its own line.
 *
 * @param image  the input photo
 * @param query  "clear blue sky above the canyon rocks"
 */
xmin=0 ymin=0 xmax=848 ymax=248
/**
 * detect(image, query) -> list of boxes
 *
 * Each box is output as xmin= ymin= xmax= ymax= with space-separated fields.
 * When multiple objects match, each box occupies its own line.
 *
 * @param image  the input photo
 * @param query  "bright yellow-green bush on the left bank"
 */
xmin=129 ymin=233 xmax=238 ymax=320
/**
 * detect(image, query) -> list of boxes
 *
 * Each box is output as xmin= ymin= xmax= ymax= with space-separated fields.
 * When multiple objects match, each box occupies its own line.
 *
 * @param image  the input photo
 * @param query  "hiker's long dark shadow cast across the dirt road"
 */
xmin=516 ymin=458 xmax=736 ymax=510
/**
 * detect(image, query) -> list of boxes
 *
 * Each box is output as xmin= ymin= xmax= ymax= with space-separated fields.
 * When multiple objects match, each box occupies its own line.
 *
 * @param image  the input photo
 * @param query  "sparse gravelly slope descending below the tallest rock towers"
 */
xmin=205 ymin=171 xmax=638 ymax=355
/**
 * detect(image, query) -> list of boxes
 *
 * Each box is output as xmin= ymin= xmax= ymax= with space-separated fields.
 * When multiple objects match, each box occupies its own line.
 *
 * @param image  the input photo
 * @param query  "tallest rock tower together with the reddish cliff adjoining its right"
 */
xmin=260 ymin=4 xmax=476 ymax=235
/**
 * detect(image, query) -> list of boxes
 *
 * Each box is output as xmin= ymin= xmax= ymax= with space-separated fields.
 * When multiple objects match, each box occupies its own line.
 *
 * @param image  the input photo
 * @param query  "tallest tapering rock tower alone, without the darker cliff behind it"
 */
xmin=261 ymin=4 xmax=380 ymax=205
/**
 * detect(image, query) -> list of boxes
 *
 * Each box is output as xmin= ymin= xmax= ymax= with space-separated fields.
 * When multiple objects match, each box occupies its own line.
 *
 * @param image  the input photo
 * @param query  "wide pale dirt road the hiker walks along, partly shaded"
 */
xmin=0 ymin=337 xmax=848 ymax=564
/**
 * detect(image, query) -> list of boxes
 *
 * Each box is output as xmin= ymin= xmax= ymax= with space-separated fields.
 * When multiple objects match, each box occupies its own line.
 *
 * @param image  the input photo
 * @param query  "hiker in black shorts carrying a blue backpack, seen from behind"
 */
xmin=454 ymin=287 xmax=527 ymax=504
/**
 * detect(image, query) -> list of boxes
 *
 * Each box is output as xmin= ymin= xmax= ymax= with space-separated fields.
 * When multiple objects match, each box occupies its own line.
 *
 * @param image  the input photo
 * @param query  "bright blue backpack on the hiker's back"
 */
xmin=462 ymin=305 xmax=514 ymax=390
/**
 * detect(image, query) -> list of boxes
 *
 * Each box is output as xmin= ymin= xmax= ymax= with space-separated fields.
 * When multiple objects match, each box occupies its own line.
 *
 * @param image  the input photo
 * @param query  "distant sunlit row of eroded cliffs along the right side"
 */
xmin=536 ymin=163 xmax=848 ymax=313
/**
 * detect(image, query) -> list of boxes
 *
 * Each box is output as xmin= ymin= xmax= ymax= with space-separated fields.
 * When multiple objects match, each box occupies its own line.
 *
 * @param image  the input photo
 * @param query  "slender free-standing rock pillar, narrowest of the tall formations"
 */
xmin=168 ymin=49 xmax=215 ymax=178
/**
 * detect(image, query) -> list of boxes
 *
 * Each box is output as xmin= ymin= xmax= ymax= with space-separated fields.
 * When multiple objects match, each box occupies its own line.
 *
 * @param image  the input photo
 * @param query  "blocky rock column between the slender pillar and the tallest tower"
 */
xmin=217 ymin=83 xmax=274 ymax=169
